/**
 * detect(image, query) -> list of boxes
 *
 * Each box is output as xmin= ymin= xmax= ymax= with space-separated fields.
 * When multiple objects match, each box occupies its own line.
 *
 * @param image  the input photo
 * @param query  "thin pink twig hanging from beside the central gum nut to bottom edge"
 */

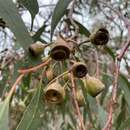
xmin=71 ymin=74 xmax=86 ymax=130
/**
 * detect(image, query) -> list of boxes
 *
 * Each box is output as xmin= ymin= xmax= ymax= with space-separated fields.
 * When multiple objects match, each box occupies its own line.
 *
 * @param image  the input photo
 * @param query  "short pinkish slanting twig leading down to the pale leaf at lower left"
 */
xmin=8 ymin=74 xmax=24 ymax=97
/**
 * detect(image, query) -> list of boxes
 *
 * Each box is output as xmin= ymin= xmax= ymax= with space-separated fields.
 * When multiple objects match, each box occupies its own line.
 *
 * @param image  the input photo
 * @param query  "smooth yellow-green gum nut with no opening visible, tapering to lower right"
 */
xmin=85 ymin=76 xmax=105 ymax=97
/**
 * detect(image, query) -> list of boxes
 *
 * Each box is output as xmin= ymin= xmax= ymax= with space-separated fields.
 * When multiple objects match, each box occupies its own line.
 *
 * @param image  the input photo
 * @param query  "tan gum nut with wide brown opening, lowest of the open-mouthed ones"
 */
xmin=44 ymin=81 xmax=65 ymax=104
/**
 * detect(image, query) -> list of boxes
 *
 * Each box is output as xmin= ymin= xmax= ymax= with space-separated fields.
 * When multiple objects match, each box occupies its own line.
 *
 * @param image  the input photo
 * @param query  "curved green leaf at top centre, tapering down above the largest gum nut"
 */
xmin=51 ymin=0 xmax=72 ymax=40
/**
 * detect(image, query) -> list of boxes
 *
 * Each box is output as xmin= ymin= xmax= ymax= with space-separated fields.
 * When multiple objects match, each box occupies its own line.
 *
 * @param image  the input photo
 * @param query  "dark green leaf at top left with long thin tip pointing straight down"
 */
xmin=20 ymin=0 xmax=39 ymax=30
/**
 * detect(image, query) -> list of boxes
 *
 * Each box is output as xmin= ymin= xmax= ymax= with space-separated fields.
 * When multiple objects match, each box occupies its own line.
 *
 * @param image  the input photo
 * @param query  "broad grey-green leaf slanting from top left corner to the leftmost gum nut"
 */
xmin=0 ymin=0 xmax=33 ymax=50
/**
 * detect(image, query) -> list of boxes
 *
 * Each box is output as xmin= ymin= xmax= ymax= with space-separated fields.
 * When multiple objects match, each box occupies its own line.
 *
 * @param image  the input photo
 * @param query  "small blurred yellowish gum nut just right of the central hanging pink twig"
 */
xmin=76 ymin=89 xmax=85 ymax=107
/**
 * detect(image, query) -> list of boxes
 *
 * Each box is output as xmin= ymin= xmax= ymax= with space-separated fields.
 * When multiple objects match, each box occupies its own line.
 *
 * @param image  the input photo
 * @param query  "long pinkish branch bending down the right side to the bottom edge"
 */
xmin=96 ymin=0 xmax=130 ymax=130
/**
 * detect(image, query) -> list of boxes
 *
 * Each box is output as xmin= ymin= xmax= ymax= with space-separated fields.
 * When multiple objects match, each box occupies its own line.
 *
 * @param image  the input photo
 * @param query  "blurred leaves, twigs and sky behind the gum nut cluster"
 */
xmin=0 ymin=0 xmax=130 ymax=130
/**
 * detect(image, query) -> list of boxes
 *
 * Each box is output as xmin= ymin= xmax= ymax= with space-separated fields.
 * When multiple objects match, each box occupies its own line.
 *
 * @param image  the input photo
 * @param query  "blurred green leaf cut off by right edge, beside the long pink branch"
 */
xmin=119 ymin=74 xmax=130 ymax=112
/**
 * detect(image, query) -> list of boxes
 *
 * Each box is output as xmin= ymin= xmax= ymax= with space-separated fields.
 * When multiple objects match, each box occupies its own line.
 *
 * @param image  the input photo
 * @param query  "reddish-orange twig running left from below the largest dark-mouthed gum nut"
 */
xmin=18 ymin=58 xmax=51 ymax=74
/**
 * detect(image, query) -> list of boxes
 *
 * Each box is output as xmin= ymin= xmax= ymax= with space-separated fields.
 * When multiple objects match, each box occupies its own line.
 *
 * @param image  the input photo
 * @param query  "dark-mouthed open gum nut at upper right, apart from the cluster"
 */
xmin=90 ymin=27 xmax=109 ymax=45
